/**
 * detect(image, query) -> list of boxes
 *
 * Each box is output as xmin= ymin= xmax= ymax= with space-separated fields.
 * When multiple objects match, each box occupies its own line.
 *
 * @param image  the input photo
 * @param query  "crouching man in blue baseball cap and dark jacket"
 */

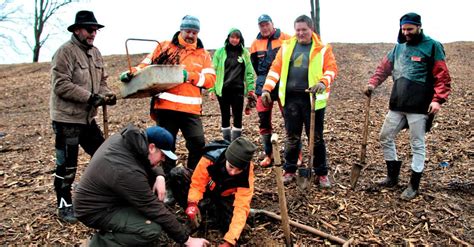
xmin=74 ymin=124 xmax=208 ymax=246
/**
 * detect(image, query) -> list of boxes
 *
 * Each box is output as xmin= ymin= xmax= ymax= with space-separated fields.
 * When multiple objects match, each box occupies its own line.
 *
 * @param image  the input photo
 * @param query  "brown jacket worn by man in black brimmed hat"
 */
xmin=49 ymin=34 xmax=111 ymax=124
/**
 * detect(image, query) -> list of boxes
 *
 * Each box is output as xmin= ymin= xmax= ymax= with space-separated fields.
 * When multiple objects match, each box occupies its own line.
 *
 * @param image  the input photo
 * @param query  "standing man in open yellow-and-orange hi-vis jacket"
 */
xmin=262 ymin=15 xmax=337 ymax=188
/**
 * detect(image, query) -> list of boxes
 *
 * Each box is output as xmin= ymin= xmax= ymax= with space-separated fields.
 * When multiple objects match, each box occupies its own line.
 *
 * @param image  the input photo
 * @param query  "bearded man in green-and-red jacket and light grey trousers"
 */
xmin=364 ymin=13 xmax=451 ymax=200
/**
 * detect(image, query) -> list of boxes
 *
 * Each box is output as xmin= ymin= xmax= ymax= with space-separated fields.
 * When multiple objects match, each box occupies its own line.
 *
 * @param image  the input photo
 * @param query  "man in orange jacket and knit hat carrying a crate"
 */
xmin=120 ymin=15 xmax=216 ymax=205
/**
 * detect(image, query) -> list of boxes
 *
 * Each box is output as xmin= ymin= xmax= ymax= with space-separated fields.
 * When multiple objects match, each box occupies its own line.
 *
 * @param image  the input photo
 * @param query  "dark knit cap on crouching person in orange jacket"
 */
xmin=225 ymin=137 xmax=257 ymax=170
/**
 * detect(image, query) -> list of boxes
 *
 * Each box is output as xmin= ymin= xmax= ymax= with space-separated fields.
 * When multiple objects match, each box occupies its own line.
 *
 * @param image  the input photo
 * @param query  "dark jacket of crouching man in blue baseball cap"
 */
xmin=74 ymin=125 xmax=189 ymax=243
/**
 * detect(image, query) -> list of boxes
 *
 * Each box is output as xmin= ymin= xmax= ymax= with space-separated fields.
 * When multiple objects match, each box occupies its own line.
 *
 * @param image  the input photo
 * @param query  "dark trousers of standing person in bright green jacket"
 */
xmin=217 ymin=88 xmax=244 ymax=129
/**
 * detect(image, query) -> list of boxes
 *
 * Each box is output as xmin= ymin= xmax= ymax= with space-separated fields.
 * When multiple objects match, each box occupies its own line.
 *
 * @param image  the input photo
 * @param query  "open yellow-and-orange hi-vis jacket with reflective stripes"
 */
xmin=263 ymin=33 xmax=337 ymax=110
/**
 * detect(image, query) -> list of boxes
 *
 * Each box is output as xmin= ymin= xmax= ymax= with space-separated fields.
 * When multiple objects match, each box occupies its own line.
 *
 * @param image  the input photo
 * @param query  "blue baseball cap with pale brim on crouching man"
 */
xmin=145 ymin=126 xmax=178 ymax=160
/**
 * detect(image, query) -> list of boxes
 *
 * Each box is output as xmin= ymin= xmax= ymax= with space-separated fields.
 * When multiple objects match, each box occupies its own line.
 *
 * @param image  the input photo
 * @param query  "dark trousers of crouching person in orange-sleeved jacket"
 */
xmin=169 ymin=166 xmax=235 ymax=233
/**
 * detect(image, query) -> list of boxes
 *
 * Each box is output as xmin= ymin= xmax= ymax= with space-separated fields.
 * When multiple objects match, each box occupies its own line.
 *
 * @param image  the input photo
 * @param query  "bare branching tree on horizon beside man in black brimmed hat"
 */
xmin=33 ymin=0 xmax=75 ymax=63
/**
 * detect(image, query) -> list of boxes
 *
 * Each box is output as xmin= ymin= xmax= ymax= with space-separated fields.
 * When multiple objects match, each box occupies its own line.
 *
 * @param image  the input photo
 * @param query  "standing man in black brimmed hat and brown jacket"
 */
xmin=50 ymin=10 xmax=116 ymax=223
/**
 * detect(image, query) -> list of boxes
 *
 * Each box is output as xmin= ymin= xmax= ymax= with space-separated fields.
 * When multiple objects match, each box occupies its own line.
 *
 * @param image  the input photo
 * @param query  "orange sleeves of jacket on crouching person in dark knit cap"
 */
xmin=188 ymin=157 xmax=254 ymax=245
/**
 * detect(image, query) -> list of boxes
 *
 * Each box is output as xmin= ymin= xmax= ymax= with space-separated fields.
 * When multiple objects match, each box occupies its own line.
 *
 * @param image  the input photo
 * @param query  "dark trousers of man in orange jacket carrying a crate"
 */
xmin=154 ymin=110 xmax=206 ymax=174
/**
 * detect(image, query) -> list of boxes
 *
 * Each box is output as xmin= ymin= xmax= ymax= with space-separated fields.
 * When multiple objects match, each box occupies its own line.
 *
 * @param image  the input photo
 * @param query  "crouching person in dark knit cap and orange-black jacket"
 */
xmin=170 ymin=137 xmax=256 ymax=247
